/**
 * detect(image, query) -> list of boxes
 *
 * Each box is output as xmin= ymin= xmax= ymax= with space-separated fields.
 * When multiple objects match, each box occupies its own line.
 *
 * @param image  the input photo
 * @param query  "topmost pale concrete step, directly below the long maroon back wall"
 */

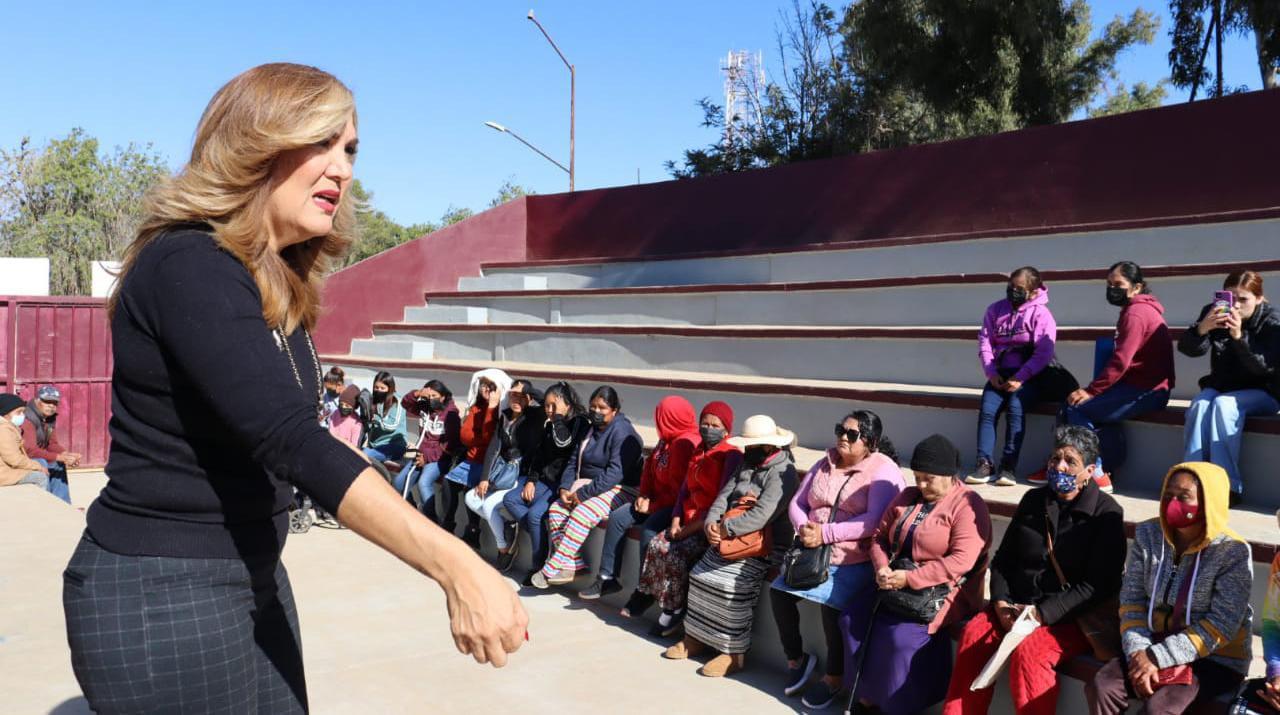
xmin=473 ymin=219 xmax=1280 ymax=290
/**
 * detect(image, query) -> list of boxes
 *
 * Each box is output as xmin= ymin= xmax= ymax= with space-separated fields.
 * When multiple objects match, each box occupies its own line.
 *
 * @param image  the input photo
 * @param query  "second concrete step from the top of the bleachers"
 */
xmin=422 ymin=267 xmax=1280 ymax=327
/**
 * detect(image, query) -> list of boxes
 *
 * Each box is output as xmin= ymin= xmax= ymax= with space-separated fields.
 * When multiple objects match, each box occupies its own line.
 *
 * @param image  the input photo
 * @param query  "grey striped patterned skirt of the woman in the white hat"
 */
xmin=685 ymin=549 xmax=769 ymax=654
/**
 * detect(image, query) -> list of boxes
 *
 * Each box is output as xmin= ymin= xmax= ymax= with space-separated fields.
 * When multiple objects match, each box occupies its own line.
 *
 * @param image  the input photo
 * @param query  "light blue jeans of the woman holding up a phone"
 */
xmin=1183 ymin=389 xmax=1280 ymax=492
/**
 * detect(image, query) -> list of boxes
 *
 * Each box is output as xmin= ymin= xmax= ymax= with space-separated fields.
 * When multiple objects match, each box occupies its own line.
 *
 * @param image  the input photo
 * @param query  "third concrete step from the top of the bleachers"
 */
xmin=374 ymin=324 xmax=1208 ymax=399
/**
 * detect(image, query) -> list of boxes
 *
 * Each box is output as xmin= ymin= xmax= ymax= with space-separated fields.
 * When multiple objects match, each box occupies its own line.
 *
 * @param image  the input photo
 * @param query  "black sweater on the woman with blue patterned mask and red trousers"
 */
xmin=991 ymin=480 xmax=1128 ymax=625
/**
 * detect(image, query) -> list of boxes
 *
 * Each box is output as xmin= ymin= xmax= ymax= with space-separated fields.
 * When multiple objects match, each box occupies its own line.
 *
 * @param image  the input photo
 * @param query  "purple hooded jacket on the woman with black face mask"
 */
xmin=978 ymin=285 xmax=1057 ymax=382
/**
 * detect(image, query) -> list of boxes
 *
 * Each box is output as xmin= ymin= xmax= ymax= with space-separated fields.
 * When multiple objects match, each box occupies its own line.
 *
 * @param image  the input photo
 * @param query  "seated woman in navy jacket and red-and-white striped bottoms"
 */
xmin=530 ymin=385 xmax=644 ymax=588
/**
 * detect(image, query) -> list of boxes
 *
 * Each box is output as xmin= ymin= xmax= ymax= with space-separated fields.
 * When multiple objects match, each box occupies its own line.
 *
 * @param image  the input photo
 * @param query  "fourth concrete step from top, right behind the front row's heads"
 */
xmin=324 ymin=356 xmax=1280 ymax=506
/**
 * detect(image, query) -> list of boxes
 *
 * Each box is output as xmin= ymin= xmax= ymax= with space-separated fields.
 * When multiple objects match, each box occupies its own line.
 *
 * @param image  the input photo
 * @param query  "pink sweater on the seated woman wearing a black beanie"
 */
xmin=872 ymin=481 xmax=991 ymax=633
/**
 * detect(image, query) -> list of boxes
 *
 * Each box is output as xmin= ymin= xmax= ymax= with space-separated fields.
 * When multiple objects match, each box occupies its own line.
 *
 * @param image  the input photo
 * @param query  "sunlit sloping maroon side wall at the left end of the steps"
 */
xmin=315 ymin=197 xmax=527 ymax=354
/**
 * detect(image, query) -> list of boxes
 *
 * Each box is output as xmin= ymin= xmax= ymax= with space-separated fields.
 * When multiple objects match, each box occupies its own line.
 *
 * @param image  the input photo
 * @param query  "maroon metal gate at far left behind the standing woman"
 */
xmin=0 ymin=295 xmax=111 ymax=467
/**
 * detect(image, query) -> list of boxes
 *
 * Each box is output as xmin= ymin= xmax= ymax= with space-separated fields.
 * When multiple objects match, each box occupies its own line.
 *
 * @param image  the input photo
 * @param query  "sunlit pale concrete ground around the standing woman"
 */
xmin=0 ymin=473 xmax=799 ymax=715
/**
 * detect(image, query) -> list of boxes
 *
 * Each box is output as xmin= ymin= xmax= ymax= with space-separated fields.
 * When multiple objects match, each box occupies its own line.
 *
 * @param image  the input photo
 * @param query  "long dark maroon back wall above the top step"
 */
xmin=529 ymin=91 xmax=1280 ymax=260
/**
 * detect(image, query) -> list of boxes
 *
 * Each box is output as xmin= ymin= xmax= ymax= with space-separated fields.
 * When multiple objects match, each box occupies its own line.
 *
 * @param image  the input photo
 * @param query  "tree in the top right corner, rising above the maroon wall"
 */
xmin=1169 ymin=0 xmax=1280 ymax=101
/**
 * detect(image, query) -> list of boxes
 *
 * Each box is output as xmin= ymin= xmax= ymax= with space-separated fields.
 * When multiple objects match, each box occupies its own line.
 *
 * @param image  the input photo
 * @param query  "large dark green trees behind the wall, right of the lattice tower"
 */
xmin=668 ymin=0 xmax=1160 ymax=177
